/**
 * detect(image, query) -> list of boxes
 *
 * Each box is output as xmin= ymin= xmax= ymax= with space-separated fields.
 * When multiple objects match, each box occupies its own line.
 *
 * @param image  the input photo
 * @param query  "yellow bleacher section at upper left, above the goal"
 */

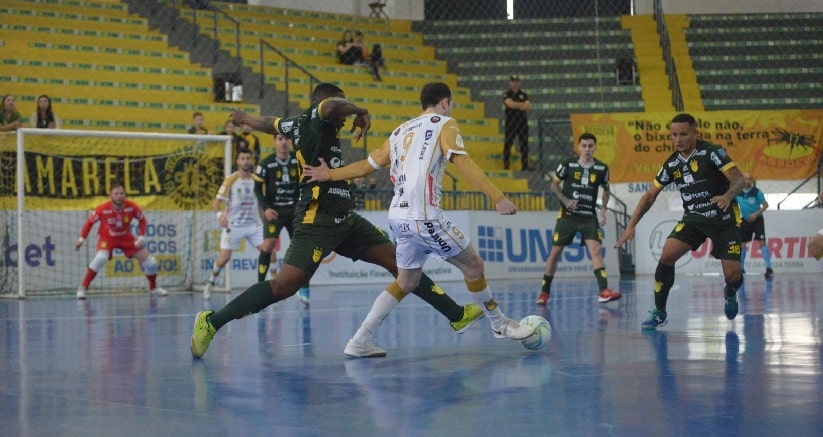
xmin=0 ymin=0 xmax=256 ymax=133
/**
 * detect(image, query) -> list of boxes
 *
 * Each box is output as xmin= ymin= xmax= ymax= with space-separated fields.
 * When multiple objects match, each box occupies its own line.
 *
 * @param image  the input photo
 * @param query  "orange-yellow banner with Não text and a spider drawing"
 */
xmin=571 ymin=110 xmax=823 ymax=183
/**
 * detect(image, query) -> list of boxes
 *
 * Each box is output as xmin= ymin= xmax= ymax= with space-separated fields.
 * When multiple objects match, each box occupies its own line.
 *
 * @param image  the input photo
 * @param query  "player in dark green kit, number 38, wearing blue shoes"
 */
xmin=614 ymin=114 xmax=743 ymax=329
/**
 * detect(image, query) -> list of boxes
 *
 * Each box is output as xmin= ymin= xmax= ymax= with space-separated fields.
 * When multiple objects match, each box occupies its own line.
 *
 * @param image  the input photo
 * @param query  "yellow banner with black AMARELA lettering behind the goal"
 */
xmin=0 ymin=131 xmax=225 ymax=210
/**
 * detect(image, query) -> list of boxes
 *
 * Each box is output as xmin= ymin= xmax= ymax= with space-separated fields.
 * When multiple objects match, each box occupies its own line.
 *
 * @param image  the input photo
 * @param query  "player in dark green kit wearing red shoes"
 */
xmin=537 ymin=132 xmax=622 ymax=305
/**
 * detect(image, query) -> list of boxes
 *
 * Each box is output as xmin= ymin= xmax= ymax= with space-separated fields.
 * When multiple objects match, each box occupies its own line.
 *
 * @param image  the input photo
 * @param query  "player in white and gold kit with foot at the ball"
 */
xmin=303 ymin=82 xmax=534 ymax=355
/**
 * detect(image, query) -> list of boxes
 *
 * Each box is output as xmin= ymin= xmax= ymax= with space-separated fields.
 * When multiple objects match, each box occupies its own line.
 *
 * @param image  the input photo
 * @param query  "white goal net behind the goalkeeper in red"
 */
xmin=0 ymin=129 xmax=231 ymax=297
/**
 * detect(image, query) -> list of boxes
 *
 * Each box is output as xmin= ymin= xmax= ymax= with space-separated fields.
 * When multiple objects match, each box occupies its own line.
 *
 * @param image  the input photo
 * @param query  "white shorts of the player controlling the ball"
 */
xmin=389 ymin=218 xmax=470 ymax=270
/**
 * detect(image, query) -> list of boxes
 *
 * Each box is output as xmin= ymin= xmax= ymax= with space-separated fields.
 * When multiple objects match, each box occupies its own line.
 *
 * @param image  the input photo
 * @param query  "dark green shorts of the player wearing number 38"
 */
xmin=668 ymin=221 xmax=740 ymax=261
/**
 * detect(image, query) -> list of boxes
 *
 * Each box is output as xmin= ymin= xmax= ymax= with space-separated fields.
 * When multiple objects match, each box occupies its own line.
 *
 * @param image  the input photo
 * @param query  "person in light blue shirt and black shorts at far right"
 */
xmin=736 ymin=173 xmax=774 ymax=279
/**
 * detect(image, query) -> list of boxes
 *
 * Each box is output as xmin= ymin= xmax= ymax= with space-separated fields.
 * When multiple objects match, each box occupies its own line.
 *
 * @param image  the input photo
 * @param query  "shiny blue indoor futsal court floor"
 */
xmin=0 ymin=272 xmax=823 ymax=437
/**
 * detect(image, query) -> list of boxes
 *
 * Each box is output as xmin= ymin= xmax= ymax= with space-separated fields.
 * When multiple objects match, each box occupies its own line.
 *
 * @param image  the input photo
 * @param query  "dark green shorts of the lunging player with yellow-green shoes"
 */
xmin=283 ymin=213 xmax=391 ymax=273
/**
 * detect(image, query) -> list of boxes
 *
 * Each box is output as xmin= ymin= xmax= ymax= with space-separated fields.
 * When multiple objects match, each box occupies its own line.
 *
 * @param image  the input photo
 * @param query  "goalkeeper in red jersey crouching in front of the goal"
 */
xmin=74 ymin=183 xmax=168 ymax=299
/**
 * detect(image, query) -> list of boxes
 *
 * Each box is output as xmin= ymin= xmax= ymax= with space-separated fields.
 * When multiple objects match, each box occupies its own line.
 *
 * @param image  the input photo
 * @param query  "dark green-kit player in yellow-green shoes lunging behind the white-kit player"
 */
xmin=191 ymin=82 xmax=484 ymax=358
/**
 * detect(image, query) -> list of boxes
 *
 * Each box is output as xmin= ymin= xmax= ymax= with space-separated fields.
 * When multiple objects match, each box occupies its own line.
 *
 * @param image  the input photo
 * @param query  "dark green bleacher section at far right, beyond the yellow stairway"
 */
xmin=686 ymin=13 xmax=823 ymax=110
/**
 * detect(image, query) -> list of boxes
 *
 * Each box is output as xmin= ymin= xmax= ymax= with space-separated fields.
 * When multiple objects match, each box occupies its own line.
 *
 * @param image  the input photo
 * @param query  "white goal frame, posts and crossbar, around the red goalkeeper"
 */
xmin=8 ymin=128 xmax=232 ymax=299
